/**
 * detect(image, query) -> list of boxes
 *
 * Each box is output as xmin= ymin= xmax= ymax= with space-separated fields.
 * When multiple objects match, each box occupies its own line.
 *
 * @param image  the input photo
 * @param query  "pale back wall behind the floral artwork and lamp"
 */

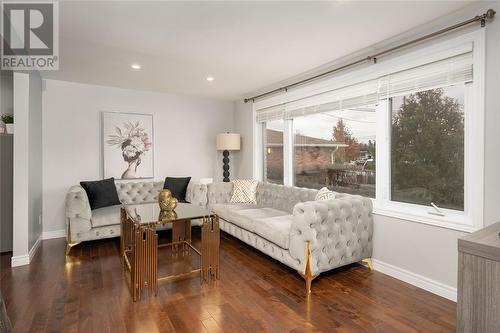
xmin=43 ymin=80 xmax=233 ymax=233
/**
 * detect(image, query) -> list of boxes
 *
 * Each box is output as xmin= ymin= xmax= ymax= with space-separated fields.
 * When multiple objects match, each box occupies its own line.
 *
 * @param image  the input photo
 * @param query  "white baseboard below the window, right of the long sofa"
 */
xmin=372 ymin=259 xmax=457 ymax=302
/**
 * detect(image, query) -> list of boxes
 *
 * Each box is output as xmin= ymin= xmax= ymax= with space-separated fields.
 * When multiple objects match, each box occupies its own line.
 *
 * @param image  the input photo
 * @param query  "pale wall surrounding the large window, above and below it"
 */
xmin=235 ymin=1 xmax=500 ymax=299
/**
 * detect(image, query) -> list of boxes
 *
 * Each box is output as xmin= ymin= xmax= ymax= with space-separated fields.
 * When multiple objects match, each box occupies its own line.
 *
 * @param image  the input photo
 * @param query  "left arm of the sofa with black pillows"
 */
xmin=66 ymin=185 xmax=92 ymax=238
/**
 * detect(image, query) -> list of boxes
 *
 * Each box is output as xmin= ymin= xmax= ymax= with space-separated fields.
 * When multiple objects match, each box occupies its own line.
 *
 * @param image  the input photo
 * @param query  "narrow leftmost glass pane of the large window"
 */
xmin=264 ymin=120 xmax=284 ymax=184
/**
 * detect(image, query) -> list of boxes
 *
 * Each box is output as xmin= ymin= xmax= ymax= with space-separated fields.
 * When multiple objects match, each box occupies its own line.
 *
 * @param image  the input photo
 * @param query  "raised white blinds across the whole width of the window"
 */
xmin=256 ymin=44 xmax=473 ymax=122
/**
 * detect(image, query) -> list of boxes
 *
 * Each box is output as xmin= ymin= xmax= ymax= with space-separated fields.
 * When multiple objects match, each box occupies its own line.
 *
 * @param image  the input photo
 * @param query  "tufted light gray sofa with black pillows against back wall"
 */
xmin=66 ymin=182 xmax=207 ymax=245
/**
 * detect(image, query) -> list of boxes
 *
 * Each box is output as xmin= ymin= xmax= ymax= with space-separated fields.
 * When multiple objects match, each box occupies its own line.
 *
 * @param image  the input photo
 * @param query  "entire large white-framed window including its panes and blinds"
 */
xmin=254 ymin=32 xmax=485 ymax=231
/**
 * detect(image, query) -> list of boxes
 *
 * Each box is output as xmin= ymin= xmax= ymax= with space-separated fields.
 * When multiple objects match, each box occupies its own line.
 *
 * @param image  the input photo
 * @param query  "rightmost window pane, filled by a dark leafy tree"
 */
xmin=391 ymin=84 xmax=465 ymax=211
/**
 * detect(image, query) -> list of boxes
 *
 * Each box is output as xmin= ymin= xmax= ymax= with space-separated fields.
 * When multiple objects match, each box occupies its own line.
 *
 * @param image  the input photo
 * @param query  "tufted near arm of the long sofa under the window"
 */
xmin=290 ymin=195 xmax=373 ymax=275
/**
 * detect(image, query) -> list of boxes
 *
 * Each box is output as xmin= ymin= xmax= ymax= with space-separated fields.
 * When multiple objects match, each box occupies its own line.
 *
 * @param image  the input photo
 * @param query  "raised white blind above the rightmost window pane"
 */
xmin=378 ymin=52 xmax=473 ymax=99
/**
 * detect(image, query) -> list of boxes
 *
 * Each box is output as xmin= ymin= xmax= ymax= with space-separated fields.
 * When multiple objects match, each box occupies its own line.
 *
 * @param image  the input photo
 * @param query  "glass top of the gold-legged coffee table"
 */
xmin=123 ymin=202 xmax=213 ymax=224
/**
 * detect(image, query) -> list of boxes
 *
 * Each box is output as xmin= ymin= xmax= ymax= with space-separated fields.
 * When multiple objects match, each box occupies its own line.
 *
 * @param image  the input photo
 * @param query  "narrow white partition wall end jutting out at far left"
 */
xmin=12 ymin=72 xmax=42 ymax=266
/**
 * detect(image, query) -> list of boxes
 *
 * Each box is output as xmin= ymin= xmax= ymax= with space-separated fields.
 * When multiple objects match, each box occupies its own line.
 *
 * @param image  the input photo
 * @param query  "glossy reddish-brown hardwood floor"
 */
xmin=0 ymin=228 xmax=456 ymax=332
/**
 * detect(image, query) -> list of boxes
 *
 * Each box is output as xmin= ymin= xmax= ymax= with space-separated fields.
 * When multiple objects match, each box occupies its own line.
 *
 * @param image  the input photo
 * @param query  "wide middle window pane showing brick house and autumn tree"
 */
xmin=293 ymin=106 xmax=376 ymax=198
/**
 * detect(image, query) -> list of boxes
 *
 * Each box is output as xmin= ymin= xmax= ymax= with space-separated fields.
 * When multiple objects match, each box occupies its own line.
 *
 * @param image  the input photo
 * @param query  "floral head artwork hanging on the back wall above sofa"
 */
xmin=102 ymin=112 xmax=154 ymax=179
